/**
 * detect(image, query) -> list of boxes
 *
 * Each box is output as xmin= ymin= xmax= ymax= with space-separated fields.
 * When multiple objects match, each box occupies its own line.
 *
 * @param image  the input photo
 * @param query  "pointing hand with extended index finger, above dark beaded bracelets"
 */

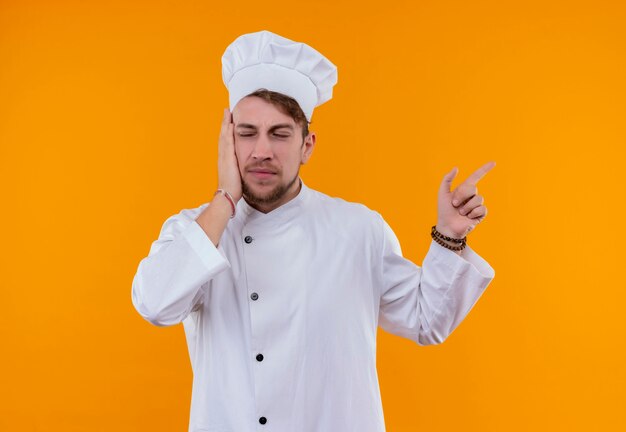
xmin=436 ymin=161 xmax=496 ymax=238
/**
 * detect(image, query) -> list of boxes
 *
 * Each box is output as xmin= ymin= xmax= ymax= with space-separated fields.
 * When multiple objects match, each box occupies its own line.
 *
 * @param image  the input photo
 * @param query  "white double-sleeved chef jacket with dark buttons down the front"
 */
xmin=132 ymin=177 xmax=495 ymax=432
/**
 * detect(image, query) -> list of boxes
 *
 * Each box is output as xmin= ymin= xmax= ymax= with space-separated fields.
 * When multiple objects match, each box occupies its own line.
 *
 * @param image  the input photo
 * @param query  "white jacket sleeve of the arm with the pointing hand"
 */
xmin=379 ymin=220 xmax=495 ymax=345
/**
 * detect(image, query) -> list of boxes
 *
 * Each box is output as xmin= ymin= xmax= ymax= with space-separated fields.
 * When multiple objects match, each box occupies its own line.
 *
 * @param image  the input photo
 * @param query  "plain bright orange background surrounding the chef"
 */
xmin=0 ymin=0 xmax=626 ymax=432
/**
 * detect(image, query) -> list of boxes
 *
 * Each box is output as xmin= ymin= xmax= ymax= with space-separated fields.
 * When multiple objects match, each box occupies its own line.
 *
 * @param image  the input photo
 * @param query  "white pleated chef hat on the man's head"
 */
xmin=222 ymin=30 xmax=337 ymax=121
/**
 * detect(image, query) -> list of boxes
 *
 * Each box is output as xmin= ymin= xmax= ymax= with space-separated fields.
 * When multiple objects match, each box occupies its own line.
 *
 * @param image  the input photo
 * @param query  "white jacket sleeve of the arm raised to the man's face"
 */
xmin=132 ymin=204 xmax=230 ymax=326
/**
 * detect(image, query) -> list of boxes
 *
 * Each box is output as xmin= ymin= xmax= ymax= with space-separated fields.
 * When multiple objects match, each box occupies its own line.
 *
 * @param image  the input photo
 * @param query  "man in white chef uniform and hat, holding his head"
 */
xmin=132 ymin=31 xmax=495 ymax=432
